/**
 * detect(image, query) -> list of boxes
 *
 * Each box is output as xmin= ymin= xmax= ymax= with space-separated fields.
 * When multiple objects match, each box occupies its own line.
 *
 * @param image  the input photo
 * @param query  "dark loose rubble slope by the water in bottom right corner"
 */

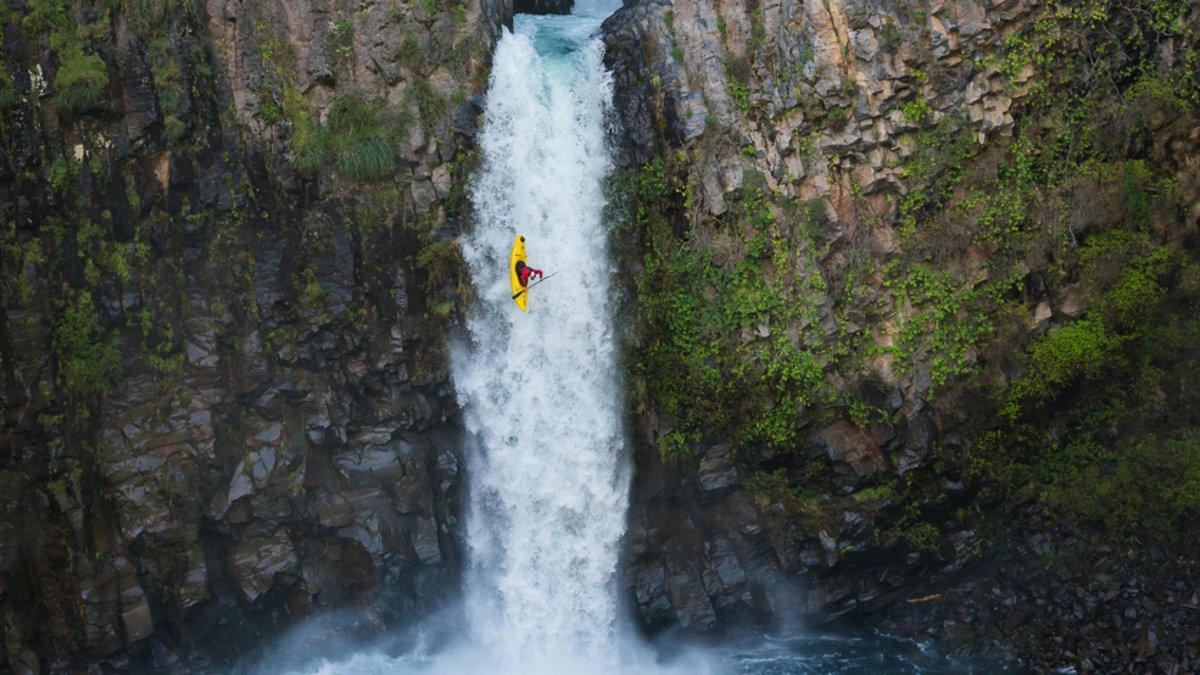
xmin=884 ymin=530 xmax=1198 ymax=671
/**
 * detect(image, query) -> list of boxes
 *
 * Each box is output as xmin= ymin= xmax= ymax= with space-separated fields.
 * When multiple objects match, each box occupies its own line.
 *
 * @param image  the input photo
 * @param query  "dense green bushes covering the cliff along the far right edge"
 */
xmin=894 ymin=2 xmax=1200 ymax=550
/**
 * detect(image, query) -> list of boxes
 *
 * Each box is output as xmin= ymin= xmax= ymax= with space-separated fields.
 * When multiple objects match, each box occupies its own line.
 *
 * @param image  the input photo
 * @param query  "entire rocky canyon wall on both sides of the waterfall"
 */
xmin=0 ymin=0 xmax=1200 ymax=673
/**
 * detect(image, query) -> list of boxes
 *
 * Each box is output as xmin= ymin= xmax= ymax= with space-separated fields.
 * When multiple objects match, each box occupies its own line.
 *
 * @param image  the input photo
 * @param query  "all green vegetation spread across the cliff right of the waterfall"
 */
xmin=619 ymin=0 xmax=1200 ymax=552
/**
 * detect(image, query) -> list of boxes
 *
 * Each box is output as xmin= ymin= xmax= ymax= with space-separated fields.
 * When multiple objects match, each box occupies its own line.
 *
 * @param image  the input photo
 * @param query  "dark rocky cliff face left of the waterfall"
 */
xmin=0 ymin=0 xmax=512 ymax=673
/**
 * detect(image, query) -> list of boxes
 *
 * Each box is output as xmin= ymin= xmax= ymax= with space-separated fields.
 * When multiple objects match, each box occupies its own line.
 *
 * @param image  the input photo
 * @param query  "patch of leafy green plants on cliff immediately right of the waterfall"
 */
xmin=624 ymin=160 xmax=828 ymax=453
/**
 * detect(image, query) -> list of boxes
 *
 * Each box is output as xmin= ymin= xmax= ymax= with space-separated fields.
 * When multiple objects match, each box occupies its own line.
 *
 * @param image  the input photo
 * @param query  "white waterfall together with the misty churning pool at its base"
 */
xmin=246 ymin=0 xmax=961 ymax=675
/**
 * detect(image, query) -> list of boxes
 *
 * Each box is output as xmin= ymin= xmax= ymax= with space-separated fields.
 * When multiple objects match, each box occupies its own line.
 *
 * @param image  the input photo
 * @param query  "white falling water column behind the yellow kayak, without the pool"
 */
xmin=451 ymin=2 xmax=628 ymax=668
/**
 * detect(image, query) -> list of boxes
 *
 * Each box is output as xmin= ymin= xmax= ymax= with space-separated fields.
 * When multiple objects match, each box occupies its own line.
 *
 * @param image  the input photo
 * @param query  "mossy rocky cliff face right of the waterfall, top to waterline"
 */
xmin=605 ymin=0 xmax=1200 ymax=669
